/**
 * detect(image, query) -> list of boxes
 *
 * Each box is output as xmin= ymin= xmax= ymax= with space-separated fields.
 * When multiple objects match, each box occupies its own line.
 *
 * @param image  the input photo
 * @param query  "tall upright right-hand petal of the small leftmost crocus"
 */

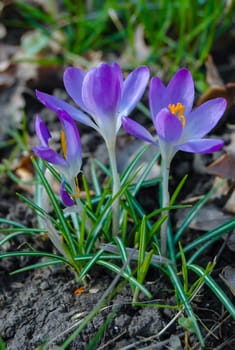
xmin=57 ymin=111 xmax=82 ymax=177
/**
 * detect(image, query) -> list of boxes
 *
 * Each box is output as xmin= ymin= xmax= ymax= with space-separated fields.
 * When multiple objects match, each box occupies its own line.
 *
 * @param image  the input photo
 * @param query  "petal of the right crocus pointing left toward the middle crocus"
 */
xmin=122 ymin=117 xmax=157 ymax=146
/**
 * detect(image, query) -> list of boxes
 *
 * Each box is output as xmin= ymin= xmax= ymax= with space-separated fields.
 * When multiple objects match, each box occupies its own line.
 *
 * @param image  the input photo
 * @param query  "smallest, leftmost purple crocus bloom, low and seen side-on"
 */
xmin=33 ymin=110 xmax=82 ymax=206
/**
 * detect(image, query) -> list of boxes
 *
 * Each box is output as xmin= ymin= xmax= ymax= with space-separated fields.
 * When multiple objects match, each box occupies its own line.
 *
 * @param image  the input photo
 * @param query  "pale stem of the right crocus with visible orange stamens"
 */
xmin=161 ymin=158 xmax=170 ymax=256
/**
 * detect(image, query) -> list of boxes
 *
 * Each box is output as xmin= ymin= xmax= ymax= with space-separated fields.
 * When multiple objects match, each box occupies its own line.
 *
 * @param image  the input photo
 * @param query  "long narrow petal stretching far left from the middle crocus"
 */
xmin=36 ymin=90 xmax=96 ymax=129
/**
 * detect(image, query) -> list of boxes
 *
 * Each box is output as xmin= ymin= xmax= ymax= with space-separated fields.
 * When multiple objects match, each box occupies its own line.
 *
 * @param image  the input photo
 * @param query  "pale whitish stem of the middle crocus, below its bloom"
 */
xmin=106 ymin=142 xmax=120 ymax=236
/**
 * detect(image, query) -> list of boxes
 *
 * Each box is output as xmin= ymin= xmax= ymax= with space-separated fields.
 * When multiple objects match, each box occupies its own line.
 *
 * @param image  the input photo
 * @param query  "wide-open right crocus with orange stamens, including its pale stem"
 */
xmin=122 ymin=68 xmax=226 ymax=255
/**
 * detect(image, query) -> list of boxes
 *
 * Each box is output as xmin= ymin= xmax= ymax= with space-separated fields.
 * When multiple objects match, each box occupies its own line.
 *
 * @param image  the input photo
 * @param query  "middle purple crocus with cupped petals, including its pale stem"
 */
xmin=36 ymin=63 xmax=149 ymax=233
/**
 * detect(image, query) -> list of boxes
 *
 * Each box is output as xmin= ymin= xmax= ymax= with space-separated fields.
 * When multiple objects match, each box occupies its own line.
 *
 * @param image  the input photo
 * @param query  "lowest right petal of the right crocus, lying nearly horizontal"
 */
xmin=177 ymin=139 xmax=224 ymax=153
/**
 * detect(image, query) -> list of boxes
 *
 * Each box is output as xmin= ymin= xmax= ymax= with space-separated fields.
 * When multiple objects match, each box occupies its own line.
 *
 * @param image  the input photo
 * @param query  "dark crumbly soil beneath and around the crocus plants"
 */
xmin=0 ymin=4 xmax=235 ymax=350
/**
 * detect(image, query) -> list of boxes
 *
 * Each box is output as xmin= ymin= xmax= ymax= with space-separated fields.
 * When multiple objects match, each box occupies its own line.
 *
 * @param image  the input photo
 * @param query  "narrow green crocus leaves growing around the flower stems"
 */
xmin=0 ymin=147 xmax=235 ymax=349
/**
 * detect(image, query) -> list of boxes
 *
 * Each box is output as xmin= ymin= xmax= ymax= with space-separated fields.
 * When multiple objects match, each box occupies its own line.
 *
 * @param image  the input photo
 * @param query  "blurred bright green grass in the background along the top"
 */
xmin=13 ymin=0 xmax=234 ymax=79
